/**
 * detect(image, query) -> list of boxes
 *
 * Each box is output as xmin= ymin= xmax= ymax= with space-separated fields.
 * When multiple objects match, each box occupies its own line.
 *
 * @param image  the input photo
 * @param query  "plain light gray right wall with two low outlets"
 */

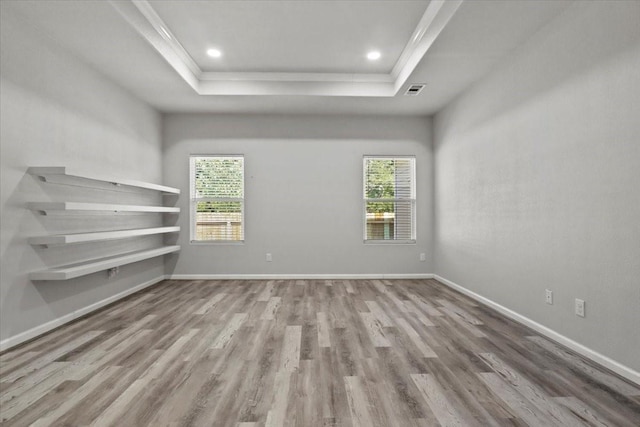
xmin=434 ymin=2 xmax=640 ymax=371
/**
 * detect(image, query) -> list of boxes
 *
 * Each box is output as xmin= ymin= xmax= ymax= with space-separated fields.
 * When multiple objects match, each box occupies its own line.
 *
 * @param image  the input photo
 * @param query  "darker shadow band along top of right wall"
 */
xmin=435 ymin=2 xmax=640 ymax=143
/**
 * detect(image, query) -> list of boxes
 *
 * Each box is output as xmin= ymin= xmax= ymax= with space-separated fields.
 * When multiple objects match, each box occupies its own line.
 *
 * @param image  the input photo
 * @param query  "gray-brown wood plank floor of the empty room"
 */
xmin=0 ymin=280 xmax=640 ymax=427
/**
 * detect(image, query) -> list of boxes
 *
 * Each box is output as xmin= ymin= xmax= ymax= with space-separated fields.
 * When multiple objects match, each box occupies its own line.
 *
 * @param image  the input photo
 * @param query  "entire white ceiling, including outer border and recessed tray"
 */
xmin=2 ymin=0 xmax=571 ymax=115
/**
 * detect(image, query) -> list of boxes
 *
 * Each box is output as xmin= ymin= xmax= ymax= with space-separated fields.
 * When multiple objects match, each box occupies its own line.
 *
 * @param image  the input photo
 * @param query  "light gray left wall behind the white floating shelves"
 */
xmin=0 ymin=8 xmax=164 ymax=347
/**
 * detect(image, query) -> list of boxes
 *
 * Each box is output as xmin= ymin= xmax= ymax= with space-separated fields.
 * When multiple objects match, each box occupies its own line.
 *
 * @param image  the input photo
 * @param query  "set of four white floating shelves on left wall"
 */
xmin=27 ymin=166 xmax=180 ymax=280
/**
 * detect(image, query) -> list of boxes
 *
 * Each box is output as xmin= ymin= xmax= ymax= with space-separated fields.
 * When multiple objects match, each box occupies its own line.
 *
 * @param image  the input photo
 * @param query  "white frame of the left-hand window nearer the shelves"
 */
xmin=189 ymin=154 xmax=246 ymax=245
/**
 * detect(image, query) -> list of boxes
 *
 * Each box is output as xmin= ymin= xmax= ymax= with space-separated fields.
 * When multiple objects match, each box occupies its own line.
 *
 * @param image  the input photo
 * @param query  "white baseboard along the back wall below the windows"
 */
xmin=167 ymin=274 xmax=433 ymax=280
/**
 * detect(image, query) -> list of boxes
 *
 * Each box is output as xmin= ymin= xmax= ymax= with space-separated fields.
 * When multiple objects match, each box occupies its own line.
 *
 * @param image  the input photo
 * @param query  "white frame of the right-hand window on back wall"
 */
xmin=362 ymin=154 xmax=418 ymax=245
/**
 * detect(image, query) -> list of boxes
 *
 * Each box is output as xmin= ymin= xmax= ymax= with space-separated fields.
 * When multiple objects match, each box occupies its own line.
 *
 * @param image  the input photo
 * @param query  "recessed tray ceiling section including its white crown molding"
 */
xmin=111 ymin=0 xmax=462 ymax=97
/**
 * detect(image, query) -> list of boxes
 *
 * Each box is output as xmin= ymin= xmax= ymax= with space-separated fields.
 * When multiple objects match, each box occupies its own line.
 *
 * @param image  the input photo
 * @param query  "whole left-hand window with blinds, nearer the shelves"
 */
xmin=190 ymin=156 xmax=244 ymax=242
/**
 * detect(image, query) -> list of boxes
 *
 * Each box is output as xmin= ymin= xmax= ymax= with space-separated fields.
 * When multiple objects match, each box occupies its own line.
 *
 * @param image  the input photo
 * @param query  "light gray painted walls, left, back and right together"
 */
xmin=0 ymin=2 xmax=640 ymax=378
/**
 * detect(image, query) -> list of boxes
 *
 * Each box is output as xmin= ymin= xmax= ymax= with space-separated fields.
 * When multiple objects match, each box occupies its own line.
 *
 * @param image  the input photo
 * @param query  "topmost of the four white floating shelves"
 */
xmin=27 ymin=166 xmax=180 ymax=194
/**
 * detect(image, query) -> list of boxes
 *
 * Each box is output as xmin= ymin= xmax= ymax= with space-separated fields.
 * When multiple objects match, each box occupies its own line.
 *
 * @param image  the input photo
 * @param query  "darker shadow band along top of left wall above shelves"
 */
xmin=0 ymin=11 xmax=159 ymax=149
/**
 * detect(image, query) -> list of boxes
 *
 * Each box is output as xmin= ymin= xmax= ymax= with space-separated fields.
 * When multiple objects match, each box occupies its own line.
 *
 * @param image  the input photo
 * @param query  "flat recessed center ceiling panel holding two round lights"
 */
xmin=149 ymin=0 xmax=429 ymax=74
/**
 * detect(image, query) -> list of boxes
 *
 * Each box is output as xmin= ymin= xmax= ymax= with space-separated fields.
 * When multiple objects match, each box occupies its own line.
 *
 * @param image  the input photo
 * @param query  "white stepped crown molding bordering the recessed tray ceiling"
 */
xmin=110 ymin=0 xmax=464 ymax=97
